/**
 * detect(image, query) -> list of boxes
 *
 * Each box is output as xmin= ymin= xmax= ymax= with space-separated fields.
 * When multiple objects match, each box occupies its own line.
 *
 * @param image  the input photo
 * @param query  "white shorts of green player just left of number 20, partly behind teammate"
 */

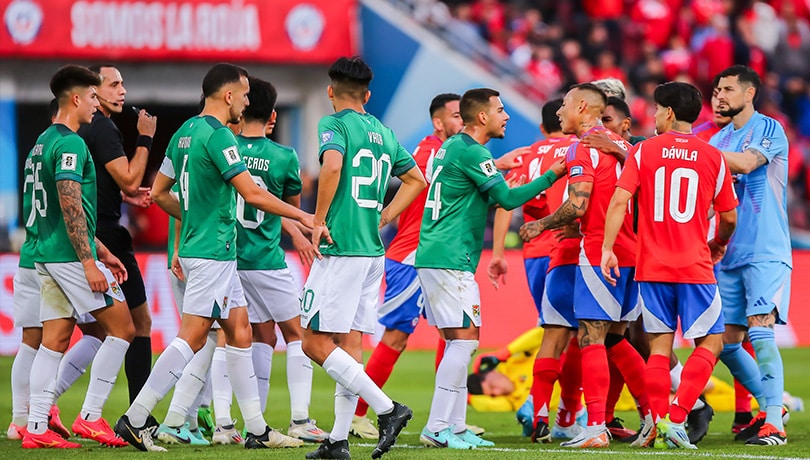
xmin=237 ymin=268 xmax=301 ymax=323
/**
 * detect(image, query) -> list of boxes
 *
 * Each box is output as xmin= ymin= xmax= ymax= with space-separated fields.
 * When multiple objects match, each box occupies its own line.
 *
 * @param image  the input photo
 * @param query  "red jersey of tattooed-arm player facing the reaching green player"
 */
xmin=568 ymin=126 xmax=636 ymax=267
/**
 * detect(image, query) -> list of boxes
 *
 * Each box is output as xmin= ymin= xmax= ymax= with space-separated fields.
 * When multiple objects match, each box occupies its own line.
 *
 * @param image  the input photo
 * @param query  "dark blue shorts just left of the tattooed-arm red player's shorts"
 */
xmin=540 ymin=265 xmax=579 ymax=329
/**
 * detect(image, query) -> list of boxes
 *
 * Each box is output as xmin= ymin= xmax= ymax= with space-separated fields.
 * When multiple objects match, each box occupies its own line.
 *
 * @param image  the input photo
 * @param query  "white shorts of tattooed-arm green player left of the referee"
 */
xmin=36 ymin=261 xmax=126 ymax=322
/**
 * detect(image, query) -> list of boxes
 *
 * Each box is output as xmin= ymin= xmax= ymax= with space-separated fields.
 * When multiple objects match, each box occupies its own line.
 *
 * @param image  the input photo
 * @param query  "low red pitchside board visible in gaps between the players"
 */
xmin=0 ymin=251 xmax=810 ymax=355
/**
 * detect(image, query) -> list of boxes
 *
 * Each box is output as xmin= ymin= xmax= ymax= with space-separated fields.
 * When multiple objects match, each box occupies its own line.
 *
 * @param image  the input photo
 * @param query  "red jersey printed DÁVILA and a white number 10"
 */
xmin=616 ymin=131 xmax=737 ymax=284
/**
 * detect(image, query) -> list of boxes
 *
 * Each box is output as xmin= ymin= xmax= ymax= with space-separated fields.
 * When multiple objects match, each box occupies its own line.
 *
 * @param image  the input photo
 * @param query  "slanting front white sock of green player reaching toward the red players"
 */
xmin=427 ymin=340 xmax=478 ymax=432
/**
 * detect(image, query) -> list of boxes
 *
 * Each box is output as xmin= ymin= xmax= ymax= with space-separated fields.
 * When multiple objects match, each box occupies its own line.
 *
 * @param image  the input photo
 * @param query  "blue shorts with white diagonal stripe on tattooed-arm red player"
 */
xmin=574 ymin=265 xmax=640 ymax=322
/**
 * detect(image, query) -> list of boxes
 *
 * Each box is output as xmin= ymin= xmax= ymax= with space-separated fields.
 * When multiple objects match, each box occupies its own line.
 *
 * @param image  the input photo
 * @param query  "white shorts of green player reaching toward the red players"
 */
xmin=416 ymin=268 xmax=481 ymax=329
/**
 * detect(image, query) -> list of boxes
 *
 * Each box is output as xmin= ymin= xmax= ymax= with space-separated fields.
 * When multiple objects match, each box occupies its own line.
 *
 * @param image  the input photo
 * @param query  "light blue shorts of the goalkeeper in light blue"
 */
xmin=717 ymin=262 xmax=792 ymax=326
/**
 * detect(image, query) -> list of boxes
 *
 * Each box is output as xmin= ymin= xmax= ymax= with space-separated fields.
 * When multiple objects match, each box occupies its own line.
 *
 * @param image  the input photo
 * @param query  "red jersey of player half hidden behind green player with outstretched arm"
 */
xmin=385 ymin=135 xmax=442 ymax=265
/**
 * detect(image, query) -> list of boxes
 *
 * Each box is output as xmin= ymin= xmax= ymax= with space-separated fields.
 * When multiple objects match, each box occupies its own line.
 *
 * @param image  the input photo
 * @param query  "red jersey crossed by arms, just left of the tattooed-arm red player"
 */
xmin=507 ymin=136 xmax=576 ymax=259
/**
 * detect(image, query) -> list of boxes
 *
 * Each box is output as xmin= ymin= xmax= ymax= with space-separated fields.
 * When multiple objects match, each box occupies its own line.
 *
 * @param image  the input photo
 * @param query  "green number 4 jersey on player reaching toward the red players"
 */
xmin=414 ymin=133 xmax=504 ymax=273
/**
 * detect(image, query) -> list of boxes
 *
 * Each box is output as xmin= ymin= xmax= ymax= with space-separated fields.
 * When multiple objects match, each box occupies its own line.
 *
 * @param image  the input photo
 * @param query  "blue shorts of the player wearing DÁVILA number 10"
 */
xmin=638 ymin=281 xmax=725 ymax=339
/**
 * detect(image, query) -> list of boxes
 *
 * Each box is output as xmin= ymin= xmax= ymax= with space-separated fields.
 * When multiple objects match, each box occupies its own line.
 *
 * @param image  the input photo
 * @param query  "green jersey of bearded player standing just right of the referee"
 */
xmin=166 ymin=116 xmax=247 ymax=260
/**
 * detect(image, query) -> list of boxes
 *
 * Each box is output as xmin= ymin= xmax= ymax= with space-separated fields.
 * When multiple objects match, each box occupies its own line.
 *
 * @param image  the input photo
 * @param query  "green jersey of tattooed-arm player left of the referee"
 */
xmin=31 ymin=124 xmax=96 ymax=263
